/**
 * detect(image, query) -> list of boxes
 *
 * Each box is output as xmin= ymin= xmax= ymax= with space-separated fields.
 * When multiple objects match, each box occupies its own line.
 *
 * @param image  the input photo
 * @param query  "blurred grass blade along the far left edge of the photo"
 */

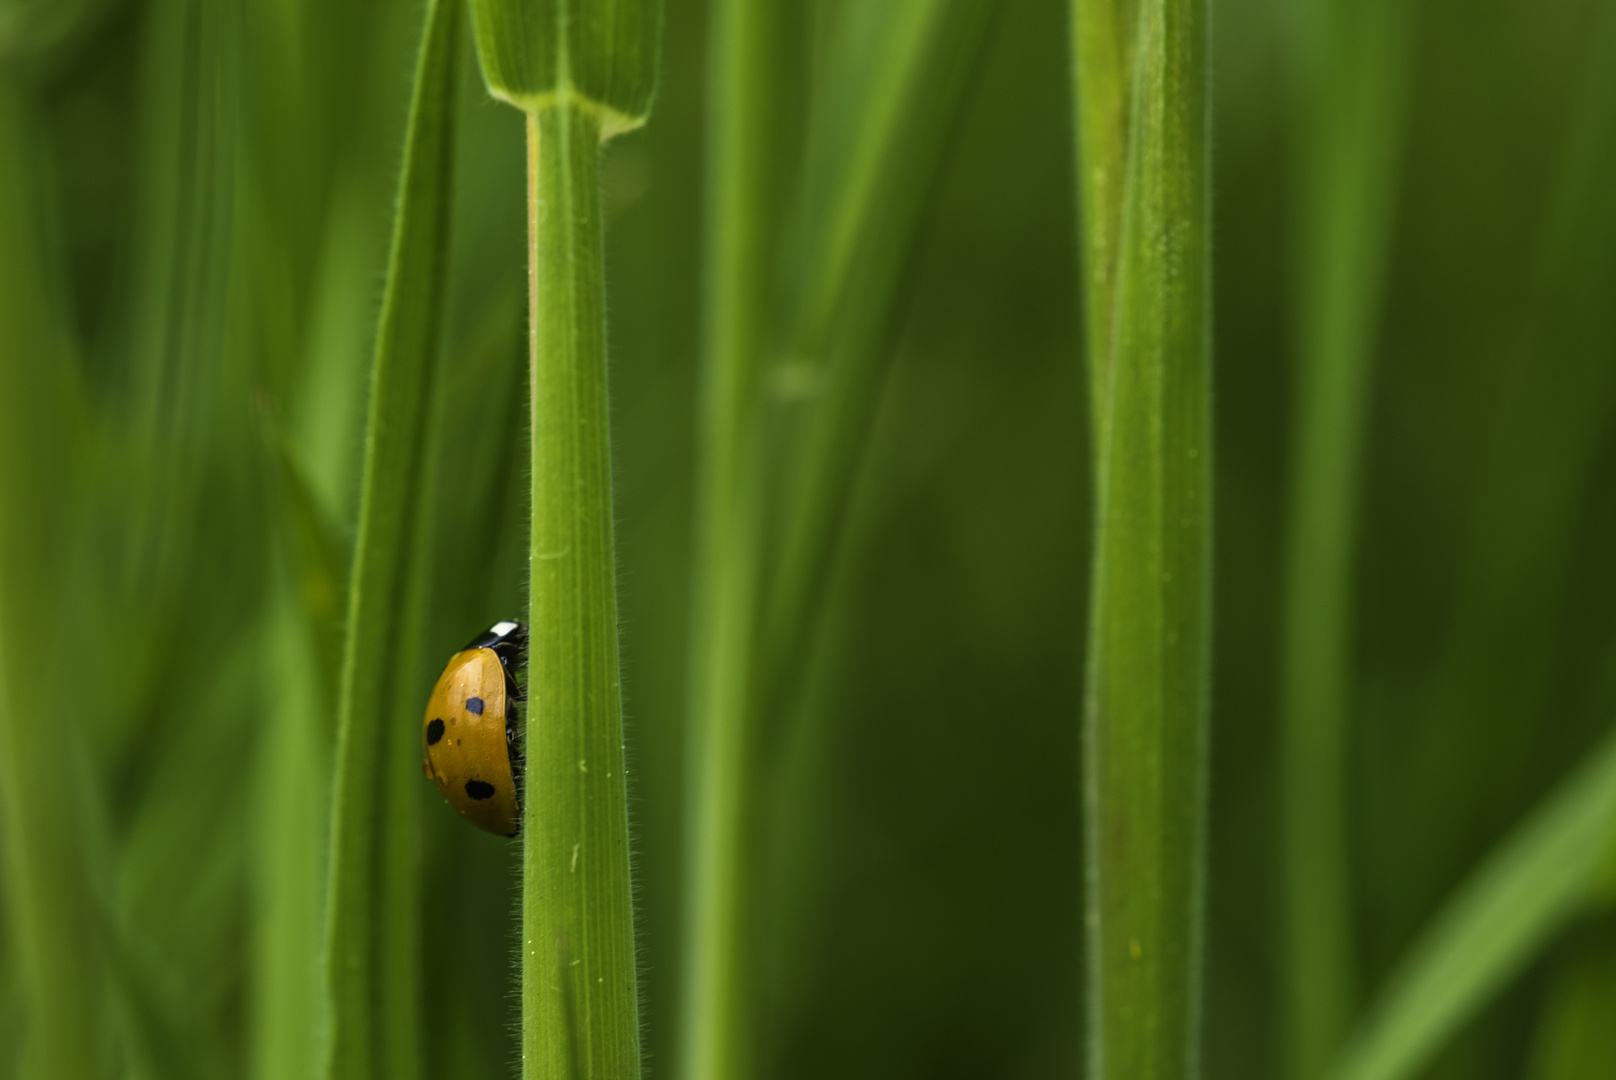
xmin=0 ymin=71 xmax=108 ymax=1080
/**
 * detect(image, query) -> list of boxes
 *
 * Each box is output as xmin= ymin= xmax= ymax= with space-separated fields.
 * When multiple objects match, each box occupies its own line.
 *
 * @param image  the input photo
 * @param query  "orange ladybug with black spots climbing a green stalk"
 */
xmin=420 ymin=621 xmax=527 ymax=836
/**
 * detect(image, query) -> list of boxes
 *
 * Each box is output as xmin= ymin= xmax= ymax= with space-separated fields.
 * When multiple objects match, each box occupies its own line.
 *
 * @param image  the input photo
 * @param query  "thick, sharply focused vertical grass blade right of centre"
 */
xmin=1073 ymin=0 xmax=1212 ymax=1080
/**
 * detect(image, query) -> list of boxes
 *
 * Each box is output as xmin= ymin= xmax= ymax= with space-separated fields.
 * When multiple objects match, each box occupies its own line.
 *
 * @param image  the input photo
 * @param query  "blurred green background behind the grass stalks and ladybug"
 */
xmin=0 ymin=0 xmax=1616 ymax=1080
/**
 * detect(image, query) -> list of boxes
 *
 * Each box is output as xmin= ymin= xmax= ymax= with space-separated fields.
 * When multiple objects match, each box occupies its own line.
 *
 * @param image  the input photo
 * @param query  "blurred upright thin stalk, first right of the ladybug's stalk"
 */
xmin=680 ymin=0 xmax=782 ymax=1080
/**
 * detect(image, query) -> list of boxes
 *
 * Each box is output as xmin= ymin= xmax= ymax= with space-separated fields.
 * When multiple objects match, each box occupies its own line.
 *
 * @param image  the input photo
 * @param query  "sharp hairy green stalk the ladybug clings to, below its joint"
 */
xmin=522 ymin=100 xmax=640 ymax=1080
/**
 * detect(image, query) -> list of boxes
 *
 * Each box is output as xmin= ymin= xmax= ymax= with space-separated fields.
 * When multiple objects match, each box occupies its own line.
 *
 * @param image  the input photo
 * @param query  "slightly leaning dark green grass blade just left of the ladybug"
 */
xmin=325 ymin=0 xmax=459 ymax=1080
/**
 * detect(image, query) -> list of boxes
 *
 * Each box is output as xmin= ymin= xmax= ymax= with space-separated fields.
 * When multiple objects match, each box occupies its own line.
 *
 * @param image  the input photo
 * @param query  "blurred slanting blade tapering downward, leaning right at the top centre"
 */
xmin=761 ymin=0 xmax=997 ymax=710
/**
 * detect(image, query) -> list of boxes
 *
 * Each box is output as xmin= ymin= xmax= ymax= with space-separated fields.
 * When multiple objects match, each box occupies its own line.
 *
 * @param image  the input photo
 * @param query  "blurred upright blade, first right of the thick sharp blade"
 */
xmin=1280 ymin=0 xmax=1411 ymax=1080
